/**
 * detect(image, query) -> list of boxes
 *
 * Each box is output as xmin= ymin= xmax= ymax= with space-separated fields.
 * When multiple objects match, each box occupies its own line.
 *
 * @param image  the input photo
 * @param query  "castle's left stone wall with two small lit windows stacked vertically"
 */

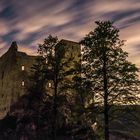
xmin=0 ymin=42 xmax=36 ymax=119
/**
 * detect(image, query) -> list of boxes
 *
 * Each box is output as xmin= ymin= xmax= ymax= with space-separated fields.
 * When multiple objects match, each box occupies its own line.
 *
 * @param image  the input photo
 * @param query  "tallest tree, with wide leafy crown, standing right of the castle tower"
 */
xmin=81 ymin=21 xmax=139 ymax=140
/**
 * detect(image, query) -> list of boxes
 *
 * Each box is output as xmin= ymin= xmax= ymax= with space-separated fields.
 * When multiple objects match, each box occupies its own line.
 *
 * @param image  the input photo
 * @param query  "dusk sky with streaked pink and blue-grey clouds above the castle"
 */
xmin=0 ymin=0 xmax=140 ymax=71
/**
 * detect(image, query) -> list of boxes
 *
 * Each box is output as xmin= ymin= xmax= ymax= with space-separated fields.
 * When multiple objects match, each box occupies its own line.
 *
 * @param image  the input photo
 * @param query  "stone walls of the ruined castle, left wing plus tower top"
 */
xmin=0 ymin=39 xmax=81 ymax=119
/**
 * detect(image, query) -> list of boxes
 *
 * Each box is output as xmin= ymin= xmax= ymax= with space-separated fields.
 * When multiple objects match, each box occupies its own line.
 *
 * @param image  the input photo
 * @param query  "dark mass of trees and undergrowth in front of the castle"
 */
xmin=0 ymin=21 xmax=139 ymax=140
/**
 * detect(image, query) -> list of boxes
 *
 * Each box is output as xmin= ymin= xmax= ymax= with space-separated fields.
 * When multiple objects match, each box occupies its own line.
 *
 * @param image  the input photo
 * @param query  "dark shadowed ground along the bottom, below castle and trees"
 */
xmin=0 ymin=94 xmax=140 ymax=140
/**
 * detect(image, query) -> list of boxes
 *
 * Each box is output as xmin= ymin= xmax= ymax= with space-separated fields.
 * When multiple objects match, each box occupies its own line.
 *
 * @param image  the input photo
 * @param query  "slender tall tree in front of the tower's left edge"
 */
xmin=38 ymin=35 xmax=74 ymax=140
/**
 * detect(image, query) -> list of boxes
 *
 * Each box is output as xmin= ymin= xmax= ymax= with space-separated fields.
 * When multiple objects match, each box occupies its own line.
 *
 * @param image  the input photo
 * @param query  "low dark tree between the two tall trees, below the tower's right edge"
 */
xmin=72 ymin=61 xmax=96 ymax=140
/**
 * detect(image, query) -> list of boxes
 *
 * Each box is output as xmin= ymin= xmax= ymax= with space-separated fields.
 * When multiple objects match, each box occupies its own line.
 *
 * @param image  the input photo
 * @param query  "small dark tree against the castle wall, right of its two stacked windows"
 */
xmin=27 ymin=56 xmax=46 ymax=100
